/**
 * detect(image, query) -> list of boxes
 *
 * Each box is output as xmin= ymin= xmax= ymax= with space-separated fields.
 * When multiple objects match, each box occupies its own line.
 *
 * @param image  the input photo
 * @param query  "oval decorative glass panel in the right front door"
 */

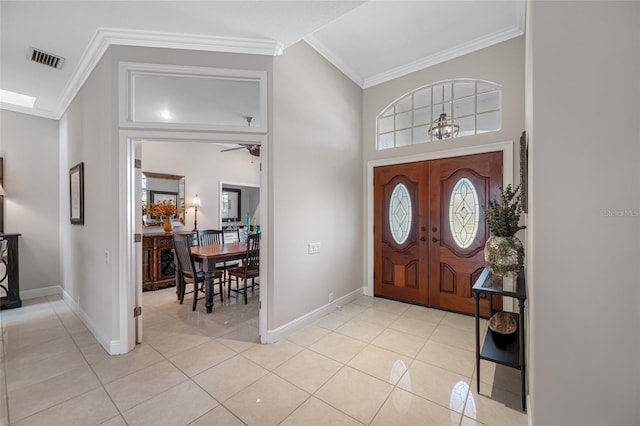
xmin=449 ymin=178 xmax=480 ymax=248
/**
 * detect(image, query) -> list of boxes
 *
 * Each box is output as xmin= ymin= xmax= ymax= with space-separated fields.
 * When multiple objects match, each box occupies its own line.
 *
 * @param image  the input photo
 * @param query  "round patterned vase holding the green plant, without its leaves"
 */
xmin=484 ymin=236 xmax=524 ymax=277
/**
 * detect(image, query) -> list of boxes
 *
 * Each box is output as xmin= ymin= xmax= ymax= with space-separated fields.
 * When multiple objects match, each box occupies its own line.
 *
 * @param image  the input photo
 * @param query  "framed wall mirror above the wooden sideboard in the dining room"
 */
xmin=142 ymin=172 xmax=185 ymax=226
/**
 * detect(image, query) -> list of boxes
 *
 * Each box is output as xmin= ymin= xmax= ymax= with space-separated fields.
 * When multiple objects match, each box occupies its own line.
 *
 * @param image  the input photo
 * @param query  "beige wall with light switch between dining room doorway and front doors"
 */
xmin=269 ymin=42 xmax=363 ymax=329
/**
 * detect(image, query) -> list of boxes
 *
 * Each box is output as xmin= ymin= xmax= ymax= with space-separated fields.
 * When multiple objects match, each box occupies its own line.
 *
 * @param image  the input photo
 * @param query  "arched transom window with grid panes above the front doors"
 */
xmin=377 ymin=79 xmax=502 ymax=149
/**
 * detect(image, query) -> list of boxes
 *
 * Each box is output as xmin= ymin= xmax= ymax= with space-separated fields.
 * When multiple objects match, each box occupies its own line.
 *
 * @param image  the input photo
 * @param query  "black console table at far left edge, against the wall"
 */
xmin=0 ymin=234 xmax=22 ymax=309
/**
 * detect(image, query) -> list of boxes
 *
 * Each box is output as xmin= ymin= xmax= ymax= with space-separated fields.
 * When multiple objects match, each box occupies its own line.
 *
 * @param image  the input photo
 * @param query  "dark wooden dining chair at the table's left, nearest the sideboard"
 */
xmin=173 ymin=234 xmax=224 ymax=311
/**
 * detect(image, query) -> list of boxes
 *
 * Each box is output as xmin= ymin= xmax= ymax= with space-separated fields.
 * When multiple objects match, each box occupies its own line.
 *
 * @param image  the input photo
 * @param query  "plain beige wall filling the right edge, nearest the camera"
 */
xmin=527 ymin=1 xmax=640 ymax=426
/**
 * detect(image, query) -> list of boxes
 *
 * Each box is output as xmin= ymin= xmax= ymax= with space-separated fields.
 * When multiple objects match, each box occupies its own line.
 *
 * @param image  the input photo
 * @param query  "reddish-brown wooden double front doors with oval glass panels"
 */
xmin=374 ymin=152 xmax=502 ymax=316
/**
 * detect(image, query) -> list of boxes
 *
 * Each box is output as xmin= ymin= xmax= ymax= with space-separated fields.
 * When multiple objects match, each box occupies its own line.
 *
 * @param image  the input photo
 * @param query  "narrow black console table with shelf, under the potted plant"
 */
xmin=473 ymin=267 xmax=527 ymax=411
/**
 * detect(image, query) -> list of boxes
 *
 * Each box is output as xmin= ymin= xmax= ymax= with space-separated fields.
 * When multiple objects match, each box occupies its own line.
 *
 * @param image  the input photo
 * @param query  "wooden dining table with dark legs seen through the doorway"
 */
xmin=191 ymin=242 xmax=247 ymax=314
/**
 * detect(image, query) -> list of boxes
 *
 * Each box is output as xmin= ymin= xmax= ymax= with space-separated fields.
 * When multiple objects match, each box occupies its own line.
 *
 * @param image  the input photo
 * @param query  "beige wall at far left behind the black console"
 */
xmin=0 ymin=110 xmax=59 ymax=298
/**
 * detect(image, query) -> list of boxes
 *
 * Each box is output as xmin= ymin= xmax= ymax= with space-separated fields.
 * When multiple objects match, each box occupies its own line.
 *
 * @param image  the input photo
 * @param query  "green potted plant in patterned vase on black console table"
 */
xmin=484 ymin=185 xmax=525 ymax=276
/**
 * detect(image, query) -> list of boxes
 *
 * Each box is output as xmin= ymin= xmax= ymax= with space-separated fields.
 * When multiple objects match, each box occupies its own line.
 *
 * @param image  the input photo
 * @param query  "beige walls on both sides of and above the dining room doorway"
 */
xmin=61 ymin=43 xmax=362 ymax=352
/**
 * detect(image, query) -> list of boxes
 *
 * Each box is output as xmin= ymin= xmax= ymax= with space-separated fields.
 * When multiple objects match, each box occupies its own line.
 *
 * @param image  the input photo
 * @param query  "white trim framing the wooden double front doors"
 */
xmin=363 ymin=141 xmax=514 ymax=296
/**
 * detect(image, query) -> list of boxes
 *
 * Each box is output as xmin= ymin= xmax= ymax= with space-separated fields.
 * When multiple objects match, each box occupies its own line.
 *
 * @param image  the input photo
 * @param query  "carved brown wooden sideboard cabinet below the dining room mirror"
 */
xmin=142 ymin=232 xmax=176 ymax=290
